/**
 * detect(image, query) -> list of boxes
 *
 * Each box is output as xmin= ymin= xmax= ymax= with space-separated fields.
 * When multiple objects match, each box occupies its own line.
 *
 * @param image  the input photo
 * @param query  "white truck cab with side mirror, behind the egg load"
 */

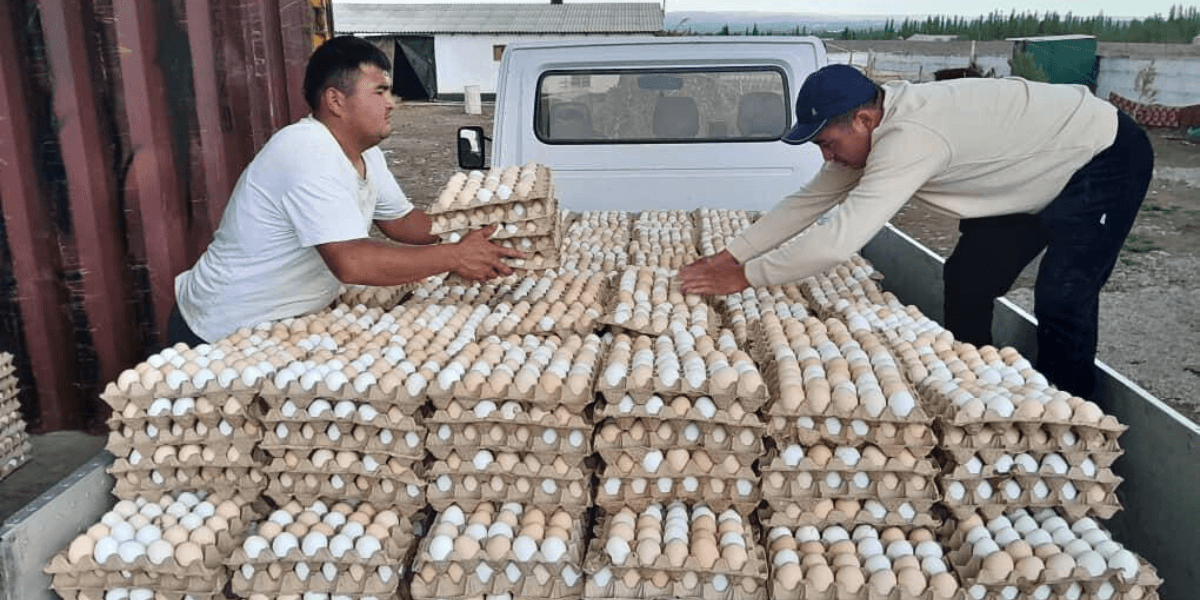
xmin=458 ymin=37 xmax=826 ymax=210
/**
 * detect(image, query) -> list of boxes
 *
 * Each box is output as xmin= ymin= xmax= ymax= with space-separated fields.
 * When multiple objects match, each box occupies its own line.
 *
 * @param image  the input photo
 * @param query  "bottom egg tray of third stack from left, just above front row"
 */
xmin=426 ymin=460 xmax=592 ymax=510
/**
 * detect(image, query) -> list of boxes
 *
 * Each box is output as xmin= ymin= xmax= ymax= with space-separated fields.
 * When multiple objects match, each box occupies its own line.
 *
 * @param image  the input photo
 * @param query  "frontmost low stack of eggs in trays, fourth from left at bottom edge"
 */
xmin=586 ymin=502 xmax=767 ymax=599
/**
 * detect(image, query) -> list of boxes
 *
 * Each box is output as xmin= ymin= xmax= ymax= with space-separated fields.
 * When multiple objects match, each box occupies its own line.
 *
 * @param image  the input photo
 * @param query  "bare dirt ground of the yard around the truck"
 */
xmin=383 ymin=103 xmax=1200 ymax=422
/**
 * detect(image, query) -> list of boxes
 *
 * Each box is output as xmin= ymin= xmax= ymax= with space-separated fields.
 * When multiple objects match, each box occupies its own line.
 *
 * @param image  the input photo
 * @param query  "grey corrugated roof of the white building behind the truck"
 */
xmin=334 ymin=1 xmax=662 ymax=35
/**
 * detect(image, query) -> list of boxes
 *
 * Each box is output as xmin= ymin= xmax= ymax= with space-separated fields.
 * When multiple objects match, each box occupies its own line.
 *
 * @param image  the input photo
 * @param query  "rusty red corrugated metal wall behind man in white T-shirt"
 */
xmin=0 ymin=0 xmax=332 ymax=431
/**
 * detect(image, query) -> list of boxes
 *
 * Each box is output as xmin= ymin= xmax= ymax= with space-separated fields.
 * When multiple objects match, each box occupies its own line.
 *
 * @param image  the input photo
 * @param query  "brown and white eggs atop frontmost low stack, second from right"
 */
xmin=767 ymin=524 xmax=960 ymax=600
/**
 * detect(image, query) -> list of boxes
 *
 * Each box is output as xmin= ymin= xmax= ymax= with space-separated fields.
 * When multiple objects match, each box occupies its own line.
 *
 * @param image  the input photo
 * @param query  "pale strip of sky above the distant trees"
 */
xmin=335 ymin=0 xmax=1183 ymax=18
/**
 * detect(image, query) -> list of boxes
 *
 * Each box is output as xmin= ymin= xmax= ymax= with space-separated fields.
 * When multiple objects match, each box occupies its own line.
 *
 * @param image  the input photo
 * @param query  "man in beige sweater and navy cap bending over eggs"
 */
xmin=680 ymin=65 xmax=1153 ymax=397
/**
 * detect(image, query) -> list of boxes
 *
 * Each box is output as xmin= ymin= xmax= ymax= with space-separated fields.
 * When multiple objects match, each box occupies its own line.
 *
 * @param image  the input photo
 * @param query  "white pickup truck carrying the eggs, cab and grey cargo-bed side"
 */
xmin=458 ymin=36 xmax=1200 ymax=600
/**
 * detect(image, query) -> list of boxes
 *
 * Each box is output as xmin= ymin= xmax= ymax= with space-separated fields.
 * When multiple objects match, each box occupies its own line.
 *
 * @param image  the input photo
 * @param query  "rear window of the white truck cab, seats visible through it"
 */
xmin=534 ymin=67 xmax=791 ymax=144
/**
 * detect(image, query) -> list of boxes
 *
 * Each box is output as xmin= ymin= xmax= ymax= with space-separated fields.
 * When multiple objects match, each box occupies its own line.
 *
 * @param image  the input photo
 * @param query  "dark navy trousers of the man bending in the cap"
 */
xmin=944 ymin=113 xmax=1154 ymax=398
